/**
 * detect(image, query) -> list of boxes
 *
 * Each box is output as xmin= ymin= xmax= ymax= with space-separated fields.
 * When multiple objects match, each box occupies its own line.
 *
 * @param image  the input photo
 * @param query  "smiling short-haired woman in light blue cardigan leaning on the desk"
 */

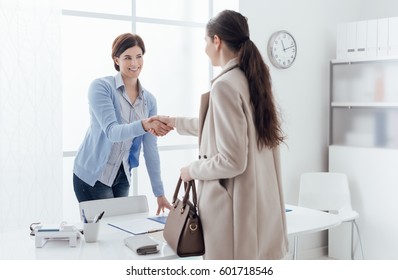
xmin=73 ymin=33 xmax=172 ymax=214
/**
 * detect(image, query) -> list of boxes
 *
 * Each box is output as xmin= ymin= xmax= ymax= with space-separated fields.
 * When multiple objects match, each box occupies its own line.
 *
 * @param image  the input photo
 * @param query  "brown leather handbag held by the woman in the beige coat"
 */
xmin=163 ymin=178 xmax=205 ymax=257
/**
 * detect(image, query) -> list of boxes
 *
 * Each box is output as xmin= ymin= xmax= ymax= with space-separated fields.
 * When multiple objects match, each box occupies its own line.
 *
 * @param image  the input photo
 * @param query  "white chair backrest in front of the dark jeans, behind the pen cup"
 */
xmin=79 ymin=195 xmax=149 ymax=219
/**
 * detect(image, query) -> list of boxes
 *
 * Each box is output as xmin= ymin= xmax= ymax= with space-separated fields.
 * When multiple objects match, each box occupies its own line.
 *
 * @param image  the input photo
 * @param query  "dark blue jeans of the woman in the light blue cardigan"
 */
xmin=73 ymin=165 xmax=130 ymax=202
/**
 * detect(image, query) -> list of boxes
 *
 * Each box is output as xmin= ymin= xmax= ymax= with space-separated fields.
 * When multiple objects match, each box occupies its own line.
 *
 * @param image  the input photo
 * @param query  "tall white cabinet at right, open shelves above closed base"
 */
xmin=329 ymin=58 xmax=398 ymax=259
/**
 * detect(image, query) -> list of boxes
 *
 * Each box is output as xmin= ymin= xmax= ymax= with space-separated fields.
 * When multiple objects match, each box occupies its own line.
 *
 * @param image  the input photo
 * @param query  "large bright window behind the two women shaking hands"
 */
xmin=62 ymin=0 xmax=238 ymax=220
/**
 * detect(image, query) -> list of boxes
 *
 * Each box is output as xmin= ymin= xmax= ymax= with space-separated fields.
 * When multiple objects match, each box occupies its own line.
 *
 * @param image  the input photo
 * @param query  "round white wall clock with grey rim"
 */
xmin=268 ymin=31 xmax=297 ymax=69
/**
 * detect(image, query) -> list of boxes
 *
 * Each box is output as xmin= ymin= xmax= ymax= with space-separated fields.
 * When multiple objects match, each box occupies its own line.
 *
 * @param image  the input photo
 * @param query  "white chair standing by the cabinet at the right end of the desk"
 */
xmin=294 ymin=172 xmax=362 ymax=259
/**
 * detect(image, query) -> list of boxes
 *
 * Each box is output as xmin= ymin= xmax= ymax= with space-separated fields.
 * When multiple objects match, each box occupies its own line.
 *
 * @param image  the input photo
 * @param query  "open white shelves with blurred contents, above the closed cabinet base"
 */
xmin=329 ymin=58 xmax=398 ymax=149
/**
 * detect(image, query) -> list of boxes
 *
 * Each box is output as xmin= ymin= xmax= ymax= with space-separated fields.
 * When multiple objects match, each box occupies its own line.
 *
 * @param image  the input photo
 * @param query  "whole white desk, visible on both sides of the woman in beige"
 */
xmin=0 ymin=205 xmax=341 ymax=260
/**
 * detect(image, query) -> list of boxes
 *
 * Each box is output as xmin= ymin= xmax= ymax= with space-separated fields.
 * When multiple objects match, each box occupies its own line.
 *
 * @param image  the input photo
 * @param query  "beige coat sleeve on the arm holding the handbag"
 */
xmin=189 ymin=81 xmax=248 ymax=180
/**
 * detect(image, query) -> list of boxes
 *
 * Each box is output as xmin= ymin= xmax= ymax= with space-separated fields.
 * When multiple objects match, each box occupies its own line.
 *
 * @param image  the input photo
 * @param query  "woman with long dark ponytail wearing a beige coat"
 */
xmin=162 ymin=11 xmax=288 ymax=259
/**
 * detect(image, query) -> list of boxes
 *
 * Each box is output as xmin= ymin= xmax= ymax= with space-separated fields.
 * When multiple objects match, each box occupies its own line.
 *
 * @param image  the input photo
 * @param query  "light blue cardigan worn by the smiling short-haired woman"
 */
xmin=73 ymin=73 xmax=164 ymax=197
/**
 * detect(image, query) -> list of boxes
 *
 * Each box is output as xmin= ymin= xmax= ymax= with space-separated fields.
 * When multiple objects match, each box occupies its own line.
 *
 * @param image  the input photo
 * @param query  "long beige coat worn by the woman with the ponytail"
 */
xmin=176 ymin=59 xmax=288 ymax=260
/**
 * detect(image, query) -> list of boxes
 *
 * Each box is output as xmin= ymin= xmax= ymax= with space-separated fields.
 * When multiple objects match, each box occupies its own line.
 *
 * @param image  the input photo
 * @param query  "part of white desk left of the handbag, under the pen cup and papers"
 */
xmin=0 ymin=213 xmax=177 ymax=260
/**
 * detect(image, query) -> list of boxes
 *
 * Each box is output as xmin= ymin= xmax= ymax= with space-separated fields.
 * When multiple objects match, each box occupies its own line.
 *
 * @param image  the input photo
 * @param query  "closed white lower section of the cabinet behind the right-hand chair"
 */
xmin=329 ymin=146 xmax=398 ymax=260
